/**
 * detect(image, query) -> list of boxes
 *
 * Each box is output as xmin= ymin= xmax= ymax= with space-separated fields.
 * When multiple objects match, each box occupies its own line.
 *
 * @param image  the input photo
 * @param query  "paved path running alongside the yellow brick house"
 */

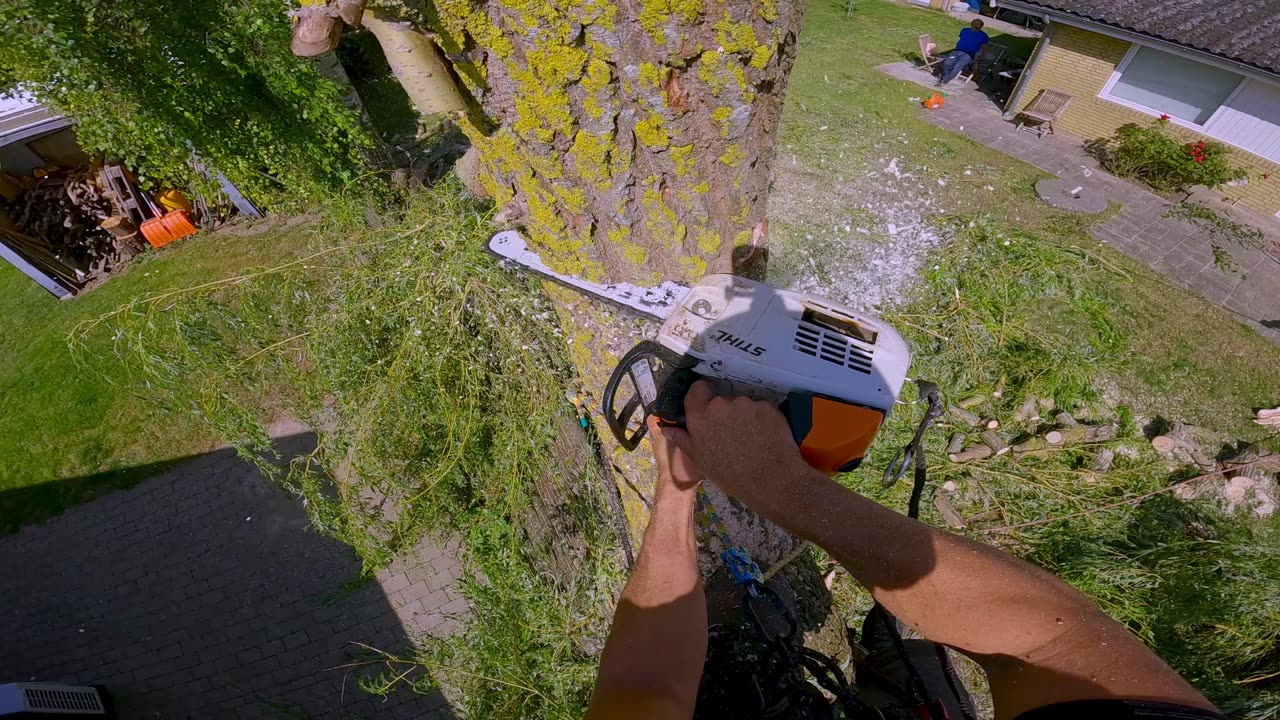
xmin=879 ymin=63 xmax=1280 ymax=343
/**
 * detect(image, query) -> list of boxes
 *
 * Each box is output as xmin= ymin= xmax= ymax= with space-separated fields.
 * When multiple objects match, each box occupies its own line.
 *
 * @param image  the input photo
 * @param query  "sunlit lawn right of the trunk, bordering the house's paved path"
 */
xmin=771 ymin=0 xmax=1280 ymax=439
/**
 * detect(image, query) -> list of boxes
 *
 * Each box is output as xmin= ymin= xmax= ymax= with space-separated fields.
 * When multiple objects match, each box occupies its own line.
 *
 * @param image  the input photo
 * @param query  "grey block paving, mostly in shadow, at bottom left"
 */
xmin=0 ymin=427 xmax=466 ymax=720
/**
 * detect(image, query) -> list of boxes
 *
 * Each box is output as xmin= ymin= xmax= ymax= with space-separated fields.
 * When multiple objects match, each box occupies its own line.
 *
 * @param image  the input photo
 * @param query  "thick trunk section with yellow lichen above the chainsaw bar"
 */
xmin=429 ymin=0 xmax=804 ymax=283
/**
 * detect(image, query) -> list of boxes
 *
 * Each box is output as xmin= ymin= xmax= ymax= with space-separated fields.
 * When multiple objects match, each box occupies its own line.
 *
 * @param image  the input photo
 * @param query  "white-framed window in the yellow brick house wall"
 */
xmin=1102 ymin=46 xmax=1244 ymax=126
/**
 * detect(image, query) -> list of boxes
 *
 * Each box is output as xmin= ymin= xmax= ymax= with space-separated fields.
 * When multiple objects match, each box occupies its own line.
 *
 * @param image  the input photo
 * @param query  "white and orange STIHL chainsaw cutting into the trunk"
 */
xmin=489 ymin=231 xmax=910 ymax=474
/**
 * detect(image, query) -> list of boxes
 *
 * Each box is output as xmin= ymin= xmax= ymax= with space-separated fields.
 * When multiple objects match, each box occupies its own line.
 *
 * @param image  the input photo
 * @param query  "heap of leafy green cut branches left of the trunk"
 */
xmin=74 ymin=183 xmax=618 ymax=717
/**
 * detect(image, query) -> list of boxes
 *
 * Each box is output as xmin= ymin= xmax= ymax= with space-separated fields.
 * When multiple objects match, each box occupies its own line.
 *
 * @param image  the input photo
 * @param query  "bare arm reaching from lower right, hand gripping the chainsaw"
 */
xmin=664 ymin=383 xmax=1212 ymax=719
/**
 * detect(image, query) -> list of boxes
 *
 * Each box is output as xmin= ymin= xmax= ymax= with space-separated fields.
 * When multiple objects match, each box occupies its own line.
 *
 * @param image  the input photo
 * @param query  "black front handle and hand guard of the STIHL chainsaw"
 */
xmin=600 ymin=340 xmax=699 ymax=451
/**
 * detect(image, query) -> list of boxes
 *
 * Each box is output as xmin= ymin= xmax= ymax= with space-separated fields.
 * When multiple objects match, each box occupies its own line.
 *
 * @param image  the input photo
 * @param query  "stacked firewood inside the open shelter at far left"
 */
xmin=0 ymin=168 xmax=143 ymax=288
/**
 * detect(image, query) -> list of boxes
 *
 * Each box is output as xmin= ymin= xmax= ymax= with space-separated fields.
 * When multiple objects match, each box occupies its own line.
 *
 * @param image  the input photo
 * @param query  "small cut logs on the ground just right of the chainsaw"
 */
xmin=947 ymin=397 xmax=1117 ymax=471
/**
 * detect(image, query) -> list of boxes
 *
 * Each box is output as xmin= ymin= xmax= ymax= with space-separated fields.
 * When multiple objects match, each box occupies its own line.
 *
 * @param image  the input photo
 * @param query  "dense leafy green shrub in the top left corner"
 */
xmin=0 ymin=0 xmax=370 ymax=206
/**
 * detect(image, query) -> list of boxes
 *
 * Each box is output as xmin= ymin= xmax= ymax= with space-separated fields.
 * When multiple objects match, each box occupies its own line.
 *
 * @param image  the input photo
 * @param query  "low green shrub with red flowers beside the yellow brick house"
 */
xmin=1105 ymin=117 xmax=1244 ymax=192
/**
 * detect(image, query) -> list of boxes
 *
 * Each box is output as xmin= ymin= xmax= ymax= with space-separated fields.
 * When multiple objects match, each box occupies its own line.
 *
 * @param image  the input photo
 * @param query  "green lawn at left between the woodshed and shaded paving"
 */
xmin=0 ymin=221 xmax=312 ymax=530
